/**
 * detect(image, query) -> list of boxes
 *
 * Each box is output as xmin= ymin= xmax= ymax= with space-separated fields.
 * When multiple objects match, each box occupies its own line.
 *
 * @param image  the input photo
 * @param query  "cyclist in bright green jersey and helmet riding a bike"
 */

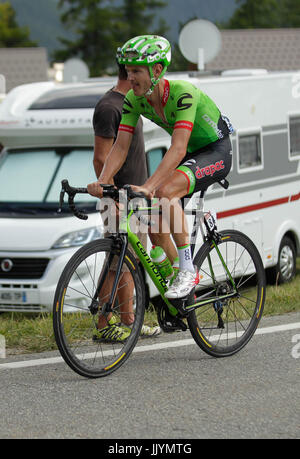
xmin=88 ymin=35 xmax=232 ymax=299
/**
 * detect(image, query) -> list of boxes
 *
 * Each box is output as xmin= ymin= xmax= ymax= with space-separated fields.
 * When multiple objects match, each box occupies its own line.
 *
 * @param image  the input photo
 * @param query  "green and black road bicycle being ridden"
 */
xmin=53 ymin=180 xmax=266 ymax=378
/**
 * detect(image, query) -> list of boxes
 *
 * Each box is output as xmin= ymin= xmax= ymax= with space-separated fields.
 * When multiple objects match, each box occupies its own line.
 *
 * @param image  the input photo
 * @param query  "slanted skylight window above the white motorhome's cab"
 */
xmin=29 ymin=86 xmax=108 ymax=110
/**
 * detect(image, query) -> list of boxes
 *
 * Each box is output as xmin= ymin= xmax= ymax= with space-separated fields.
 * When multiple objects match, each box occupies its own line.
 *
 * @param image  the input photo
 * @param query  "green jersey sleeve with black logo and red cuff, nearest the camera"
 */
xmin=174 ymin=85 xmax=199 ymax=131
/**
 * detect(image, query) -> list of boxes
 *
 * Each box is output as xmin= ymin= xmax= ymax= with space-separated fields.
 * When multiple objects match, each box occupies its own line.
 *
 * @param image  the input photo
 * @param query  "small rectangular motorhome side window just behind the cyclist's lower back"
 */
xmin=238 ymin=133 xmax=263 ymax=172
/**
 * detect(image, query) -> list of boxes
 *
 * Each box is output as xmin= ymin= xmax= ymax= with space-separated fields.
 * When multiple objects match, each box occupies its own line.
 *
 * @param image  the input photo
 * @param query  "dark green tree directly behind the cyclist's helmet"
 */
xmin=54 ymin=0 xmax=167 ymax=76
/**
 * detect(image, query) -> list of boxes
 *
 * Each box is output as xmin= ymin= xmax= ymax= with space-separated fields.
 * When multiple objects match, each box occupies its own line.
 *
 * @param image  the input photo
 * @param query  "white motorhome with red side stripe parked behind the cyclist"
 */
xmin=0 ymin=71 xmax=300 ymax=311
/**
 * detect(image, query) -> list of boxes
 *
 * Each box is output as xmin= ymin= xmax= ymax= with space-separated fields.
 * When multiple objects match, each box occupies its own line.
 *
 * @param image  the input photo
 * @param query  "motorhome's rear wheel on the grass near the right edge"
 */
xmin=267 ymin=236 xmax=297 ymax=284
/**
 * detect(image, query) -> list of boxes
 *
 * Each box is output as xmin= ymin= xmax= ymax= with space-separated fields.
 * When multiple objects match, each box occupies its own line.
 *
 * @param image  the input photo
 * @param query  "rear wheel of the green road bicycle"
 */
xmin=187 ymin=230 xmax=266 ymax=357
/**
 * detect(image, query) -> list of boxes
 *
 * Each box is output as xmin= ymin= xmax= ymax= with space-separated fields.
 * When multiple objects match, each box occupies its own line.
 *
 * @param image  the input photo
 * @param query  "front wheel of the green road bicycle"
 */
xmin=53 ymin=240 xmax=145 ymax=377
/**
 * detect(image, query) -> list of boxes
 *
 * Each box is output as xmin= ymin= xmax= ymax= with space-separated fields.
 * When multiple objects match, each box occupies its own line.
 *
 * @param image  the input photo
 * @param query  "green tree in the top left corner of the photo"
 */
xmin=0 ymin=2 xmax=37 ymax=48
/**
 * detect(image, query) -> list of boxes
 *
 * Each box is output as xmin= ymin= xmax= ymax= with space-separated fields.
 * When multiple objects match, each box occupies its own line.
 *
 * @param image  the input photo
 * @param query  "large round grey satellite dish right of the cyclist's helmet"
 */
xmin=179 ymin=19 xmax=222 ymax=70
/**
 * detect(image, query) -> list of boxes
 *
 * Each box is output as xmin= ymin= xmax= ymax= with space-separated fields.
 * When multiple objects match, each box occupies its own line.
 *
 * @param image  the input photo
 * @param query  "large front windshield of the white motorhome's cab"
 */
xmin=0 ymin=147 xmax=96 ymax=217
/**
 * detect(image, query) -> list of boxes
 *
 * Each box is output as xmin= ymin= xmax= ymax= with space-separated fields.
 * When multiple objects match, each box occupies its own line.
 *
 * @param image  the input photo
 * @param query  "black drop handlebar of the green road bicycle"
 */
xmin=58 ymin=179 xmax=150 ymax=220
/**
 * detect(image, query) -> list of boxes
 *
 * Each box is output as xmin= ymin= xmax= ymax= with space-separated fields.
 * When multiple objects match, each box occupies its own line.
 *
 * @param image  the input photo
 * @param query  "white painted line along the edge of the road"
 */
xmin=0 ymin=322 xmax=300 ymax=370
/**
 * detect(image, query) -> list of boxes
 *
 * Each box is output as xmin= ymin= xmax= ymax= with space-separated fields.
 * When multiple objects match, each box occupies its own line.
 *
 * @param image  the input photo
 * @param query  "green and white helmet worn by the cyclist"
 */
xmin=117 ymin=35 xmax=171 ymax=95
